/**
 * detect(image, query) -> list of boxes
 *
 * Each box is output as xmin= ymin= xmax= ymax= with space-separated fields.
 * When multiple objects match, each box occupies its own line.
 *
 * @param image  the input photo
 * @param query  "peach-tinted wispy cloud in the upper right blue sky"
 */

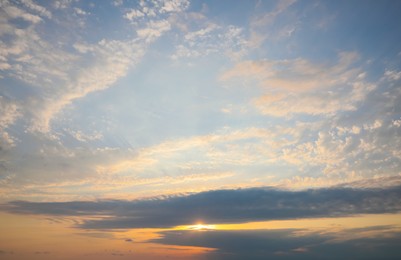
xmin=220 ymin=52 xmax=376 ymax=117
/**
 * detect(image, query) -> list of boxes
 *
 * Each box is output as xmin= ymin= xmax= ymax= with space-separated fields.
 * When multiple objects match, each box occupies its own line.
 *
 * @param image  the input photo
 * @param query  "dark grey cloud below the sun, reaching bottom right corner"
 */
xmin=152 ymin=226 xmax=401 ymax=259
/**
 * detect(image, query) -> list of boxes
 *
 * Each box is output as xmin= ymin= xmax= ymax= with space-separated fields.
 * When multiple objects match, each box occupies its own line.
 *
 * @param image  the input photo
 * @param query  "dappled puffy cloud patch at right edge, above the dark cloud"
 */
xmin=281 ymin=111 xmax=401 ymax=183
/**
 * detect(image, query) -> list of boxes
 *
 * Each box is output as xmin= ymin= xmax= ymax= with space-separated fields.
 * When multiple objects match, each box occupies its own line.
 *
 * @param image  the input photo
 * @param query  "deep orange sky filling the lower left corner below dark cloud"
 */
xmin=0 ymin=213 xmax=214 ymax=260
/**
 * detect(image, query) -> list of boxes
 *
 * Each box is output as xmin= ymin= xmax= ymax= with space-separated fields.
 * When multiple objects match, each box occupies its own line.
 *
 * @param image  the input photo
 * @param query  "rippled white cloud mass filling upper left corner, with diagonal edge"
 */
xmin=0 ymin=0 xmax=188 ymax=133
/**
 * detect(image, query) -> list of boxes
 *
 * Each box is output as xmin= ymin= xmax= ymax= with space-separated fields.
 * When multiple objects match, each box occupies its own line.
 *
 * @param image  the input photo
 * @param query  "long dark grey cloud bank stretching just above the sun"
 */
xmin=2 ymin=186 xmax=401 ymax=229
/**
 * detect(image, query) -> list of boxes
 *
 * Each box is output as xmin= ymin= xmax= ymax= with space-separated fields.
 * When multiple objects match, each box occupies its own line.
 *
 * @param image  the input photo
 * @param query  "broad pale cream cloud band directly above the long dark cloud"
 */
xmin=2 ymin=111 xmax=401 ymax=201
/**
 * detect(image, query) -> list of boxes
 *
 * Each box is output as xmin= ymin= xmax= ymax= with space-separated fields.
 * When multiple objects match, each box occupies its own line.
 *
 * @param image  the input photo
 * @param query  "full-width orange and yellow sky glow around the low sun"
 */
xmin=0 ymin=213 xmax=401 ymax=260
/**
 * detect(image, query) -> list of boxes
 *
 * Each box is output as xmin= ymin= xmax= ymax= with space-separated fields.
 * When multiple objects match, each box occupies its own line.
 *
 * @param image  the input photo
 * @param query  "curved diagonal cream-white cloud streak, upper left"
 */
xmin=30 ymin=40 xmax=144 ymax=132
